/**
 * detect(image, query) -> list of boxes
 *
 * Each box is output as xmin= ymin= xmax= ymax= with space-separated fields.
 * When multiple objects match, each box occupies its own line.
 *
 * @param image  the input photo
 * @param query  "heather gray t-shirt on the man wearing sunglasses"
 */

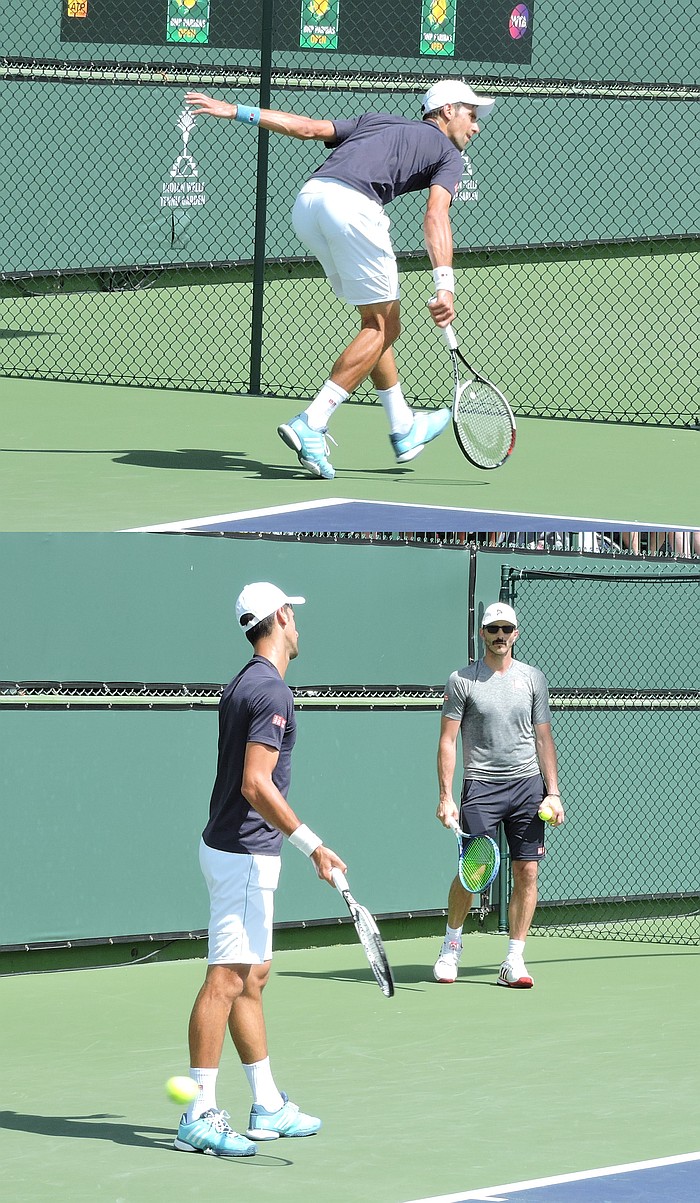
xmin=443 ymin=660 xmax=552 ymax=781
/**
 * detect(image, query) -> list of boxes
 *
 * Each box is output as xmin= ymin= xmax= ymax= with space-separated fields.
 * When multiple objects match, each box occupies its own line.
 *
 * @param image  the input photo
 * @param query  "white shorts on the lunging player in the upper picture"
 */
xmin=292 ymin=177 xmax=399 ymax=306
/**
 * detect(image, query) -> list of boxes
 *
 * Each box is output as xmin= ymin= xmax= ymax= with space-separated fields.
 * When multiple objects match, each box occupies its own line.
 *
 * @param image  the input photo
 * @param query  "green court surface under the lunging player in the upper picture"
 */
xmin=0 ymin=379 xmax=698 ymax=531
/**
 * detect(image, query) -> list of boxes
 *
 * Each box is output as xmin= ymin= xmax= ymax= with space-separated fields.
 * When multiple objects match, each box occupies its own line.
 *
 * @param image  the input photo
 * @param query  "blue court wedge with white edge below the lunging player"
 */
xmin=123 ymin=497 xmax=686 ymax=534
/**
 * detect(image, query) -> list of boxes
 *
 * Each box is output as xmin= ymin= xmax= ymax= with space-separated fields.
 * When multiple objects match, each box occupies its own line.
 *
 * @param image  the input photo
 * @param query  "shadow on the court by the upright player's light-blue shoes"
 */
xmin=0 ymin=1112 xmax=293 ymax=1166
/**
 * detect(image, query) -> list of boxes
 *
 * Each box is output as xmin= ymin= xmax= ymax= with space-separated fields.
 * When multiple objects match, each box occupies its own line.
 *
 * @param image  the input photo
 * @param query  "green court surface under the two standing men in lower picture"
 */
xmin=0 ymin=938 xmax=700 ymax=1203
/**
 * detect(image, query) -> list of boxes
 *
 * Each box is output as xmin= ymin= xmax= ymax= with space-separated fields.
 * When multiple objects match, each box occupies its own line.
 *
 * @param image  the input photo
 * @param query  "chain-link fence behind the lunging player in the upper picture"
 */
xmin=0 ymin=0 xmax=700 ymax=426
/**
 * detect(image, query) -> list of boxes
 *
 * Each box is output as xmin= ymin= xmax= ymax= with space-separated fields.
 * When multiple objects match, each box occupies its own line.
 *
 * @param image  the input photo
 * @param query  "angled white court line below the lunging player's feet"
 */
xmin=121 ymin=497 xmax=693 ymax=534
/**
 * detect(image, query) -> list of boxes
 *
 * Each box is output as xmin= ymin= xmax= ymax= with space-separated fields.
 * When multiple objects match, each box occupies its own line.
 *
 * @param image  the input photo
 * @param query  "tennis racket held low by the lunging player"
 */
xmin=443 ymin=326 xmax=515 ymax=468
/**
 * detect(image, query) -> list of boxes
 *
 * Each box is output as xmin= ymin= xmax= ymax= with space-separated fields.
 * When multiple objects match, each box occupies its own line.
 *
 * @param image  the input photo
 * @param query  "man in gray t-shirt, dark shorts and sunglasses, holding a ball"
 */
xmin=433 ymin=602 xmax=564 ymax=990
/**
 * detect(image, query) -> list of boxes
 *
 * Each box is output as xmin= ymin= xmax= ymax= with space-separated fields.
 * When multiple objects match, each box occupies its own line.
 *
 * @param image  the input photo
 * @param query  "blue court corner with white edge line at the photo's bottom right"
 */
xmin=401 ymin=1152 xmax=700 ymax=1203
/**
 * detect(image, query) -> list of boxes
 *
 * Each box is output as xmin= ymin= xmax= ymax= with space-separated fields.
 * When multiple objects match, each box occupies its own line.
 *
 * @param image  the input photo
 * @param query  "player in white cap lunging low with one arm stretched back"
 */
xmin=185 ymin=79 xmax=494 ymax=480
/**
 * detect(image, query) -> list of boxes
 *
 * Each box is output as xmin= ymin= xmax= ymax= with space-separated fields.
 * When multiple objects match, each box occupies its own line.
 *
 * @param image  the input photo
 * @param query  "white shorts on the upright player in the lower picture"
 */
xmin=200 ymin=840 xmax=281 ymax=965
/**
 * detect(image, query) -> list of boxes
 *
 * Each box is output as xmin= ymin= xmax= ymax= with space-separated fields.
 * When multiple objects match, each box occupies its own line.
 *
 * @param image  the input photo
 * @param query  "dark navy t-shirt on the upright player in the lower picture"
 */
xmin=202 ymin=656 xmax=297 ymax=857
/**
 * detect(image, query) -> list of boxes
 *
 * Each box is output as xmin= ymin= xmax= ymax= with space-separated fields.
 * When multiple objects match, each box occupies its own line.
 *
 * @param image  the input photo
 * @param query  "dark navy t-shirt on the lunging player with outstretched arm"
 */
xmin=312 ymin=113 xmax=464 ymax=205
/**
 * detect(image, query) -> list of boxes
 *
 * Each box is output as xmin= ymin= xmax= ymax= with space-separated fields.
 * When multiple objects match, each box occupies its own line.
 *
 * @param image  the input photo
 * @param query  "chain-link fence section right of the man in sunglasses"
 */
xmin=500 ymin=563 xmax=700 ymax=944
